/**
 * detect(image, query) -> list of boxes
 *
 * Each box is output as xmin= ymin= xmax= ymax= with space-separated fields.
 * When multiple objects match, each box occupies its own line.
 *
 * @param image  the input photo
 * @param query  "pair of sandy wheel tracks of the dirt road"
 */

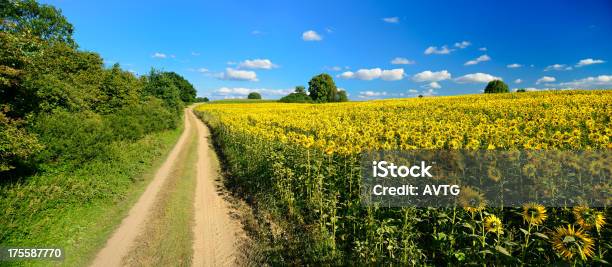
xmin=91 ymin=109 xmax=244 ymax=266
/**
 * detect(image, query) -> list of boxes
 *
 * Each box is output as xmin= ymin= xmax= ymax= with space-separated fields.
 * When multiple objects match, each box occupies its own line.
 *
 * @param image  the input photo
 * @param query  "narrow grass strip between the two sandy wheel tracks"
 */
xmin=124 ymin=121 xmax=198 ymax=266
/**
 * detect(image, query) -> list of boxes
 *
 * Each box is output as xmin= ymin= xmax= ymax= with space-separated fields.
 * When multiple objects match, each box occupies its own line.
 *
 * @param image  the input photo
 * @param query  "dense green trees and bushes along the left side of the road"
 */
xmin=0 ymin=0 xmax=196 ymax=178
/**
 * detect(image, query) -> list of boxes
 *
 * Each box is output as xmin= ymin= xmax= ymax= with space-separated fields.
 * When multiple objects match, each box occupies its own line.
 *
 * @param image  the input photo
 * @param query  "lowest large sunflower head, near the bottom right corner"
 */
xmin=551 ymin=224 xmax=594 ymax=260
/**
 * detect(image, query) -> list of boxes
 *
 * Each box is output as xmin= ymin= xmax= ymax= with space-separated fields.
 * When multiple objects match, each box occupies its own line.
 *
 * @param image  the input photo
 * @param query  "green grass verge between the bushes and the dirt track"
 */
xmin=0 ymin=120 xmax=182 ymax=266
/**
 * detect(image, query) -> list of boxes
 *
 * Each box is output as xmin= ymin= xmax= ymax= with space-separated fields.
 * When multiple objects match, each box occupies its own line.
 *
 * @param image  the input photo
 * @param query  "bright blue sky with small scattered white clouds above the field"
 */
xmin=43 ymin=0 xmax=612 ymax=100
